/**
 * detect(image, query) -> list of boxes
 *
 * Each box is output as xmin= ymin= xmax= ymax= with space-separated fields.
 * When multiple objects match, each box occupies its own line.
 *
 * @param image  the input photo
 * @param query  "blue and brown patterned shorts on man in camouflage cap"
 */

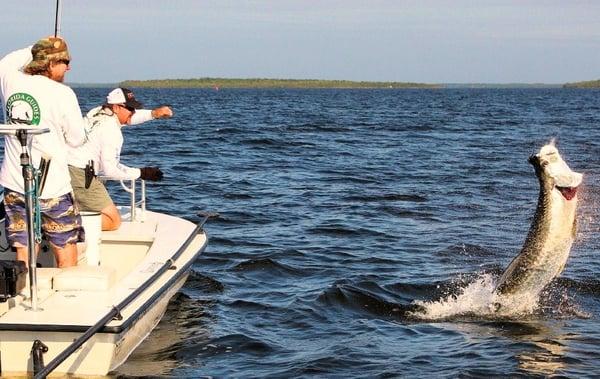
xmin=4 ymin=188 xmax=85 ymax=248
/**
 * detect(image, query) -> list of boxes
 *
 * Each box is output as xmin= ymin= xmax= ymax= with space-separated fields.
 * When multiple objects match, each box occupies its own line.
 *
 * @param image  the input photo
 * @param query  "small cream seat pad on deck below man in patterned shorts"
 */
xmin=52 ymin=265 xmax=115 ymax=291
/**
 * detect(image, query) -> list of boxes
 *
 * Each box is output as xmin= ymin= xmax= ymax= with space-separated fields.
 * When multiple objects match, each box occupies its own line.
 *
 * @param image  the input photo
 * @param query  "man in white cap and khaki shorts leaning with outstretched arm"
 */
xmin=68 ymin=88 xmax=173 ymax=230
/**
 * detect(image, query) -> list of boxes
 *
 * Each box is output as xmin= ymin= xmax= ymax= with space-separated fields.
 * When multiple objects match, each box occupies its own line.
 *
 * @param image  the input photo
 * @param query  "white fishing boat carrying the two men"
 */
xmin=0 ymin=127 xmax=209 ymax=377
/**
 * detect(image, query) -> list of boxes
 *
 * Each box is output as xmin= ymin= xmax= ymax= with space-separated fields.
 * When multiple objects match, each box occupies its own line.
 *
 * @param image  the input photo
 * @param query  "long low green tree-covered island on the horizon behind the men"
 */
xmin=119 ymin=78 xmax=441 ymax=88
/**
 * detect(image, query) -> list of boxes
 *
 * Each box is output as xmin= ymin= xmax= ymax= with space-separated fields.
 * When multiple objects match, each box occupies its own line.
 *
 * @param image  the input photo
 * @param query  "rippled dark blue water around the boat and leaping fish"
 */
xmin=77 ymin=88 xmax=600 ymax=378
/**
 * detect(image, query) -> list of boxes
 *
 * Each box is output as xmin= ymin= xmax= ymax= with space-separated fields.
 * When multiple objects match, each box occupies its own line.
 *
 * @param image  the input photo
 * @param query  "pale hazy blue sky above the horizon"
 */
xmin=0 ymin=0 xmax=600 ymax=83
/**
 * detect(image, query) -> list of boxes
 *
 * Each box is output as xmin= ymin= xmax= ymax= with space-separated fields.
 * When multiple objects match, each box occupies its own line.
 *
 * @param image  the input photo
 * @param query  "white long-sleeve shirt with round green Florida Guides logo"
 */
xmin=0 ymin=47 xmax=86 ymax=199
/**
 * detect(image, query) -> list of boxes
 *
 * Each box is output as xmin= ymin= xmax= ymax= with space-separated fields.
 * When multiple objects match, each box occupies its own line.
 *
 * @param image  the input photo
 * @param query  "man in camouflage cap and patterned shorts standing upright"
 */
xmin=0 ymin=37 xmax=85 ymax=267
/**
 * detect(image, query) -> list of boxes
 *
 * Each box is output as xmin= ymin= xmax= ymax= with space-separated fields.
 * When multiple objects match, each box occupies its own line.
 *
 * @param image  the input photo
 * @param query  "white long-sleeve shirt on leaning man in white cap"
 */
xmin=68 ymin=107 xmax=152 ymax=179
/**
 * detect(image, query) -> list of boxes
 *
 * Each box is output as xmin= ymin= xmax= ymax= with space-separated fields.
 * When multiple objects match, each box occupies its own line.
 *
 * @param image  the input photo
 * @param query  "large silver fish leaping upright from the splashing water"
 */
xmin=495 ymin=141 xmax=583 ymax=302
